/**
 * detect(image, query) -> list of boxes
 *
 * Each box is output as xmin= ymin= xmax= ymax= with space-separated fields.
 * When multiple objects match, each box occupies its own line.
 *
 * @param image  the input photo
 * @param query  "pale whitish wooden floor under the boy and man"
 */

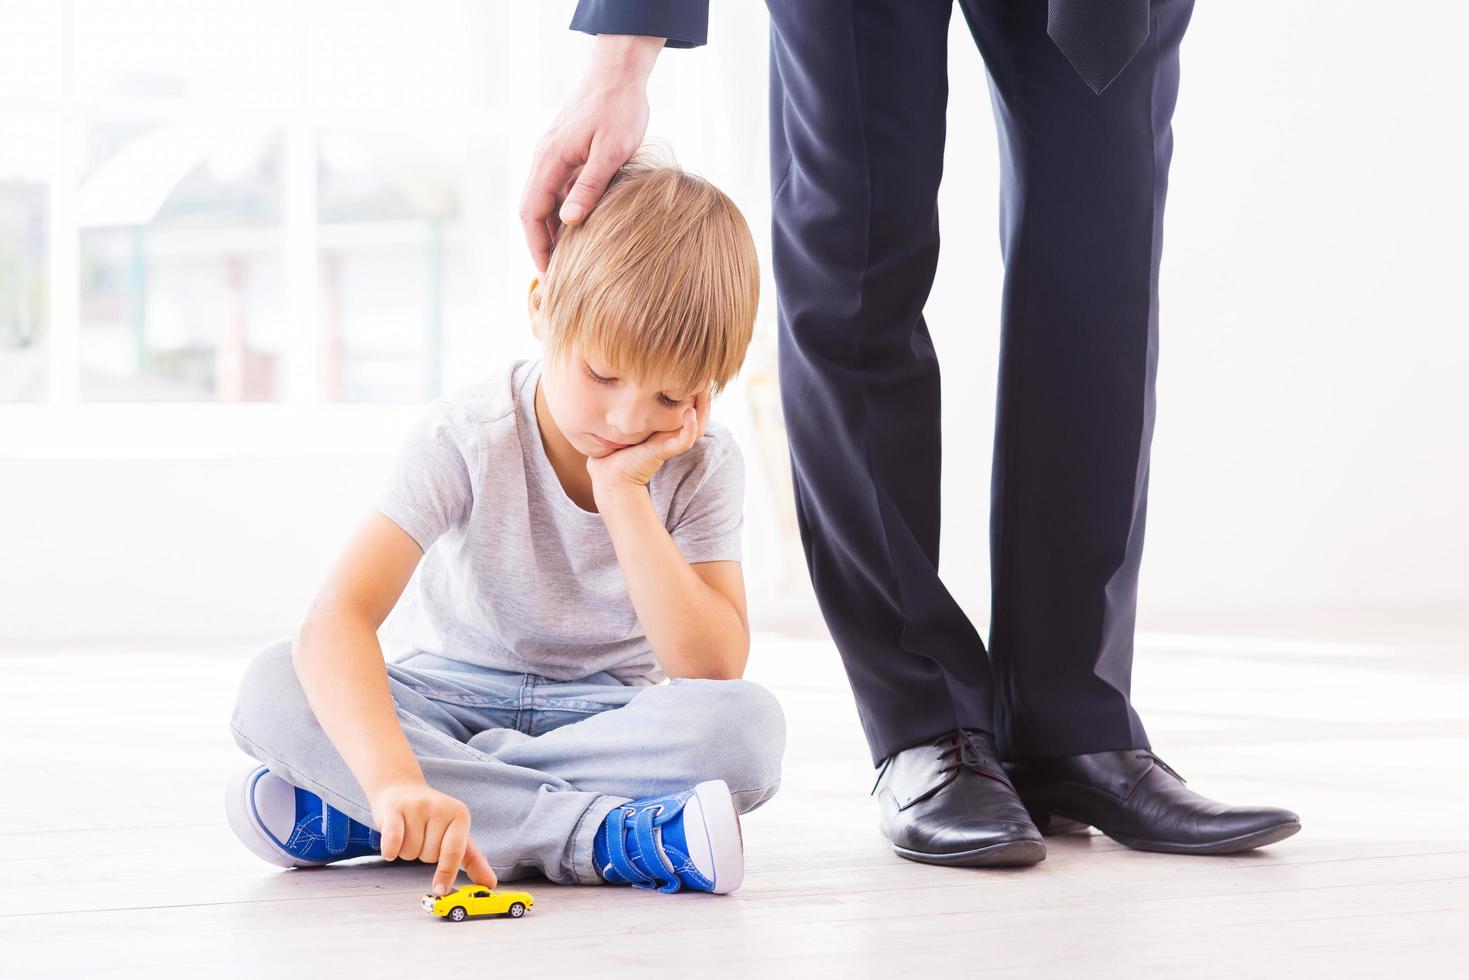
xmin=0 ymin=616 xmax=1469 ymax=979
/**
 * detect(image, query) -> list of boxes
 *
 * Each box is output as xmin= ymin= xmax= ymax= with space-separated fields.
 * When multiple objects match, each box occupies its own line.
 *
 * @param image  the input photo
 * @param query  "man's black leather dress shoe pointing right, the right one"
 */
xmin=1005 ymin=749 xmax=1300 ymax=854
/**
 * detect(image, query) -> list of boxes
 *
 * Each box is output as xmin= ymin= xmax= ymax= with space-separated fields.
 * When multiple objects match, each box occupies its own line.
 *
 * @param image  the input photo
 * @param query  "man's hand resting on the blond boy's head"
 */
xmin=520 ymin=34 xmax=667 ymax=273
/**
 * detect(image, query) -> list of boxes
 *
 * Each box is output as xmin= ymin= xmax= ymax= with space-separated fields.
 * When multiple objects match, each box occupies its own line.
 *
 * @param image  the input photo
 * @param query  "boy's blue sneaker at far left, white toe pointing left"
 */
xmin=225 ymin=765 xmax=382 ymax=868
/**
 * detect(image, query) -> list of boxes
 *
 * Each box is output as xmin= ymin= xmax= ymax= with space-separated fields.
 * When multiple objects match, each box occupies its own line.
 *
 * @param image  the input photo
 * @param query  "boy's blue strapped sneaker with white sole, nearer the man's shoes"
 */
xmin=592 ymin=779 xmax=745 ymax=895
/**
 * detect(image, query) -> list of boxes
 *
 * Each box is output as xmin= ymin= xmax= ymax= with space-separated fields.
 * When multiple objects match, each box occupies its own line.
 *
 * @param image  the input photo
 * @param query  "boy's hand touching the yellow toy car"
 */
xmin=369 ymin=782 xmax=497 ymax=895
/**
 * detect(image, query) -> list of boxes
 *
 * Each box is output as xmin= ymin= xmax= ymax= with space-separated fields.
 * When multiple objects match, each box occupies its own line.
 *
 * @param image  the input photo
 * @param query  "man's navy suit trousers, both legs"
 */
xmin=768 ymin=0 xmax=1193 ymax=763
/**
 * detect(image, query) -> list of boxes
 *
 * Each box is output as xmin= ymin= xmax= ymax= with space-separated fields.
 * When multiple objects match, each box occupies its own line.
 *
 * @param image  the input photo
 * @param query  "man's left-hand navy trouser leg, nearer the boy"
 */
xmin=768 ymin=0 xmax=993 ymax=763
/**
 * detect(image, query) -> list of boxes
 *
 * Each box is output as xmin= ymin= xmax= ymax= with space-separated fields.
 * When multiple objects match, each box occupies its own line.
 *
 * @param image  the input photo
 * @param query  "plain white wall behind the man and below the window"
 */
xmin=0 ymin=0 xmax=1469 ymax=641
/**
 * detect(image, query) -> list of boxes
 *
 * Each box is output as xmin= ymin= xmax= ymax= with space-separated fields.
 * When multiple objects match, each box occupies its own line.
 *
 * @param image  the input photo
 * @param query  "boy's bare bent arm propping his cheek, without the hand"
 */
xmin=596 ymin=485 xmax=749 ymax=680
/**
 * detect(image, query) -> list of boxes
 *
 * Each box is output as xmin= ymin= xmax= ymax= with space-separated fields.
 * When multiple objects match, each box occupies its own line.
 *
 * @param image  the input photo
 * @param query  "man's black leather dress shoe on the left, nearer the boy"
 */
xmin=873 ymin=729 xmax=1046 ymax=867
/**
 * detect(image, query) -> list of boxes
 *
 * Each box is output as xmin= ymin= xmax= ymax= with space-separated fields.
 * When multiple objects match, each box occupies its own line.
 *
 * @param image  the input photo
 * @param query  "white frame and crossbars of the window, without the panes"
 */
xmin=0 ymin=0 xmax=544 ymax=458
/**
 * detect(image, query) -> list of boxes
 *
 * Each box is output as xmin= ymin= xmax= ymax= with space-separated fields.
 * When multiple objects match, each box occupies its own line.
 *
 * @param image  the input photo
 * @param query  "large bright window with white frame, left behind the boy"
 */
xmin=0 ymin=0 xmax=528 ymax=407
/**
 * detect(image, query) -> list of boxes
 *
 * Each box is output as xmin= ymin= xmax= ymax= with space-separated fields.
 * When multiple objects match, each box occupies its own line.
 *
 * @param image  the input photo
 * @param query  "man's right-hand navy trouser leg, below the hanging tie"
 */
xmin=961 ymin=0 xmax=1193 ymax=758
